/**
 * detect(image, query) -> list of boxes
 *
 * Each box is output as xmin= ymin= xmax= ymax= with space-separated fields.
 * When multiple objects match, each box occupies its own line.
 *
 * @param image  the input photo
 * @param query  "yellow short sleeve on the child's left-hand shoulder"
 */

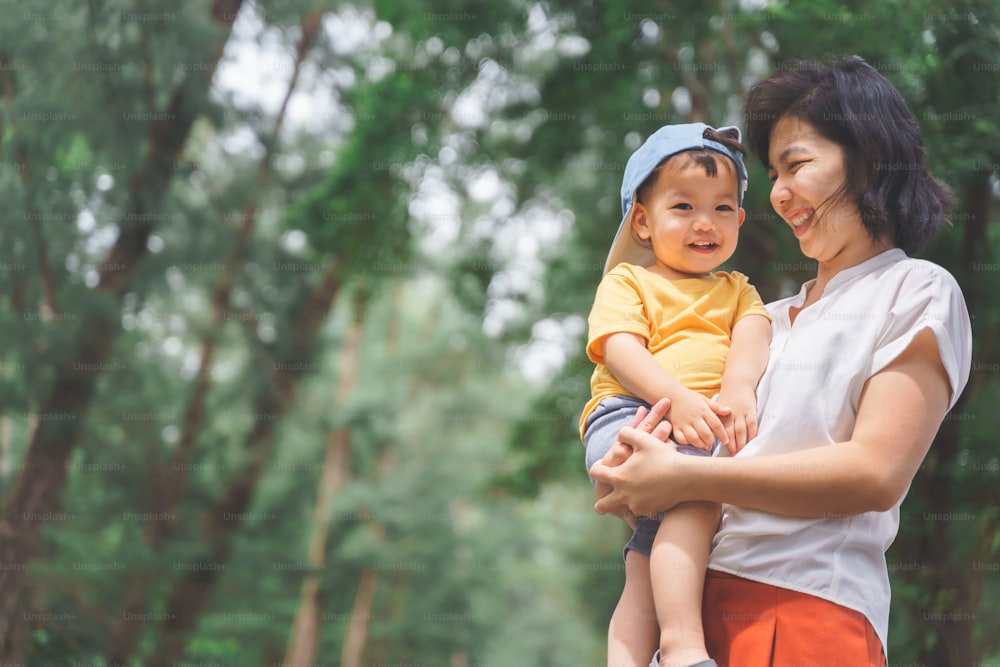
xmin=587 ymin=264 xmax=650 ymax=364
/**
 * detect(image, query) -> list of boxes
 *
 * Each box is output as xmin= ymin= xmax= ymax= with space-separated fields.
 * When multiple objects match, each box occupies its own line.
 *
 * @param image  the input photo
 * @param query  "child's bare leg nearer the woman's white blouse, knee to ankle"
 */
xmin=649 ymin=502 xmax=720 ymax=667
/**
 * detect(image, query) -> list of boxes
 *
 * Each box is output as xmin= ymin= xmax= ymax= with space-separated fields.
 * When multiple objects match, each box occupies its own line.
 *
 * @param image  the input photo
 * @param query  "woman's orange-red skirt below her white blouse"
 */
xmin=702 ymin=570 xmax=886 ymax=667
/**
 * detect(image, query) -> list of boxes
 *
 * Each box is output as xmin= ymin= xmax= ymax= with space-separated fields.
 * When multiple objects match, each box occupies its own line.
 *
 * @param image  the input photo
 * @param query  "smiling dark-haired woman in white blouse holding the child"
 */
xmin=591 ymin=57 xmax=972 ymax=667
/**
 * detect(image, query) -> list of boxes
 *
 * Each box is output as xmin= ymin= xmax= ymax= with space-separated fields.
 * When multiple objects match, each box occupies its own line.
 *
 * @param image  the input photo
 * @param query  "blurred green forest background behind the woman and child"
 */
xmin=0 ymin=0 xmax=1000 ymax=667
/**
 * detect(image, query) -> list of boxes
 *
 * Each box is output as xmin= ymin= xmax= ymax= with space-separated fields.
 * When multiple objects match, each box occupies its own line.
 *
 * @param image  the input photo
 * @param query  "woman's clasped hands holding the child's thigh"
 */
xmin=590 ymin=398 xmax=683 ymax=520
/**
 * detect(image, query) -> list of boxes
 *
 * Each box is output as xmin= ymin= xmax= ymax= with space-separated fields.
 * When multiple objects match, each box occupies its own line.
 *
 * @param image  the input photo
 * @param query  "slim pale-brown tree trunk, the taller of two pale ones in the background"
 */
xmin=284 ymin=306 xmax=363 ymax=665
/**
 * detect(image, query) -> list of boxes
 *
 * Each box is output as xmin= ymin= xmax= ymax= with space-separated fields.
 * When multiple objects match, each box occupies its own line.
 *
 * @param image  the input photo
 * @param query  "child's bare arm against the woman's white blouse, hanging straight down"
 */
xmin=719 ymin=315 xmax=771 ymax=454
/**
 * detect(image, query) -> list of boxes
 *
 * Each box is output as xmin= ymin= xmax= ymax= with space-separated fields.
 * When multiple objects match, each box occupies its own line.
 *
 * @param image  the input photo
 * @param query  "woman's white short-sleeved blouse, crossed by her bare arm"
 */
xmin=709 ymin=249 xmax=972 ymax=647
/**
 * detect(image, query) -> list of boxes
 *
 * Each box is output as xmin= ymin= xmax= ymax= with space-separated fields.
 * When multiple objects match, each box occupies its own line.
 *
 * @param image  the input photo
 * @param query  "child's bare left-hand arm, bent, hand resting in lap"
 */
xmin=601 ymin=332 xmax=732 ymax=450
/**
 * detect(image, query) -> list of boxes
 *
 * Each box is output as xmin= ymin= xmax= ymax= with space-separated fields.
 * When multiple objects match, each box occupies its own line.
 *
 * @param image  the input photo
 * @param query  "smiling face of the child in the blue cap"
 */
xmin=632 ymin=154 xmax=745 ymax=280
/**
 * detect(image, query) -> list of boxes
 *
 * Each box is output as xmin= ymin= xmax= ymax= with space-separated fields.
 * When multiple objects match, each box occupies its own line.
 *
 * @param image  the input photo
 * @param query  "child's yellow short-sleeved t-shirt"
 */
xmin=580 ymin=263 xmax=771 ymax=437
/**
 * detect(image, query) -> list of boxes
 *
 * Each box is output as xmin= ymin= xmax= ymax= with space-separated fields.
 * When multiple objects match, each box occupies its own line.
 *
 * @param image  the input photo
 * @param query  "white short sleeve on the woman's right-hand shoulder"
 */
xmin=869 ymin=262 xmax=972 ymax=410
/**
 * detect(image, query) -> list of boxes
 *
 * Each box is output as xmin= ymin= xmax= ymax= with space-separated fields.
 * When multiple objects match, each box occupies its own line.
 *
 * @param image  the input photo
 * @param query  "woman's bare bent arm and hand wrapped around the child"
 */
xmin=591 ymin=330 xmax=950 ymax=518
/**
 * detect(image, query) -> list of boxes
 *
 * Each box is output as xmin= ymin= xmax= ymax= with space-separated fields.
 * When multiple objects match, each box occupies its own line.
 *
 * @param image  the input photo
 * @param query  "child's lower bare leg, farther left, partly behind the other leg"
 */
xmin=608 ymin=550 xmax=660 ymax=667
